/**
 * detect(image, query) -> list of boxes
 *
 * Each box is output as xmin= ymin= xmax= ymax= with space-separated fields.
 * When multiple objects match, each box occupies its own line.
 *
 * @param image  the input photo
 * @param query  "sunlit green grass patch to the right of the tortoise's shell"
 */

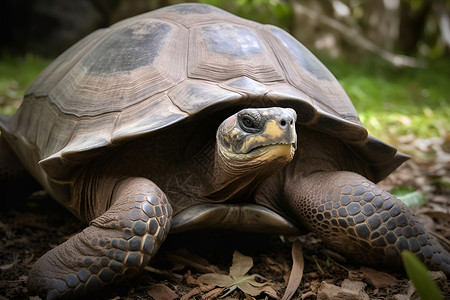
xmin=322 ymin=58 xmax=450 ymax=142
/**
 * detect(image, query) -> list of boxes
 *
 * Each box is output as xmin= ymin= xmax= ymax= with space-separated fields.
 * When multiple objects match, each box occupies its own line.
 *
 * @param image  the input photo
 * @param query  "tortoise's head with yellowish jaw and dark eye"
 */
xmin=217 ymin=107 xmax=297 ymax=171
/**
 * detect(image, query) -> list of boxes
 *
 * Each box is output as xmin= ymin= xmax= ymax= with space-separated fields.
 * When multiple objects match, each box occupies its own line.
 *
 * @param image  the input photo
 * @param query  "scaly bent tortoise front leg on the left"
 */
xmin=28 ymin=178 xmax=172 ymax=299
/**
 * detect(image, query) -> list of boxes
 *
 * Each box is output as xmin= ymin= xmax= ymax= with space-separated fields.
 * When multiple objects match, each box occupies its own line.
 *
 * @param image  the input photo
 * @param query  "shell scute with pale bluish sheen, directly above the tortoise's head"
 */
xmin=188 ymin=20 xmax=285 ymax=83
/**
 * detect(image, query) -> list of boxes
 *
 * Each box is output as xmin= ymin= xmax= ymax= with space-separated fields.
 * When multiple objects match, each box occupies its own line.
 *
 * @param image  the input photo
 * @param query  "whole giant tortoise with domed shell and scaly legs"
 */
xmin=0 ymin=4 xmax=450 ymax=299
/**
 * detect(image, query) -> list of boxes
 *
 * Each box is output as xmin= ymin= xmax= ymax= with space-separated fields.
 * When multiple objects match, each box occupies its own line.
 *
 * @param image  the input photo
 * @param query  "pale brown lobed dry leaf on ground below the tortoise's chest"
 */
xmin=198 ymin=251 xmax=278 ymax=299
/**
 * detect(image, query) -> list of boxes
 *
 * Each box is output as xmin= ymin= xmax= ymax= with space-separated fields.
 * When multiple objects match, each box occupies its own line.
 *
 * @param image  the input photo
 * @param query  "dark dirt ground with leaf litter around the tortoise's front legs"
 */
xmin=0 ymin=137 xmax=450 ymax=300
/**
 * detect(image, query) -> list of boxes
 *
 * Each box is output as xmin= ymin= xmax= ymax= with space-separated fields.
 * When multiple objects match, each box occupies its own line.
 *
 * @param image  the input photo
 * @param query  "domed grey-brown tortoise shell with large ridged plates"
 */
xmin=0 ymin=4 xmax=405 ymax=199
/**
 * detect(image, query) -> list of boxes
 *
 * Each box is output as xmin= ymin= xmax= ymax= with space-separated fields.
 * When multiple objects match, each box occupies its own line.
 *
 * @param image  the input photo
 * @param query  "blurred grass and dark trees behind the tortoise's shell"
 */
xmin=0 ymin=0 xmax=450 ymax=147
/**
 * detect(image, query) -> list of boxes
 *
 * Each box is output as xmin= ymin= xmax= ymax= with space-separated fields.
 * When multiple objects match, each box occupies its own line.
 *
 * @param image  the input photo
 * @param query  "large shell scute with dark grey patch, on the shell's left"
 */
xmin=44 ymin=19 xmax=187 ymax=117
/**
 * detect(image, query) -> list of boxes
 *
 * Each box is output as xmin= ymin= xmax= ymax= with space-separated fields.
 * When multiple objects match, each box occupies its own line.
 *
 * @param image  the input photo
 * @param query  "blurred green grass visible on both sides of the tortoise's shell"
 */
xmin=0 ymin=54 xmax=450 ymax=144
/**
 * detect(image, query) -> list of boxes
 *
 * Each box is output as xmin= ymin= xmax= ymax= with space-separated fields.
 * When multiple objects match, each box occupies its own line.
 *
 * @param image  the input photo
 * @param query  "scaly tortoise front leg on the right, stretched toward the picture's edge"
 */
xmin=285 ymin=172 xmax=450 ymax=273
